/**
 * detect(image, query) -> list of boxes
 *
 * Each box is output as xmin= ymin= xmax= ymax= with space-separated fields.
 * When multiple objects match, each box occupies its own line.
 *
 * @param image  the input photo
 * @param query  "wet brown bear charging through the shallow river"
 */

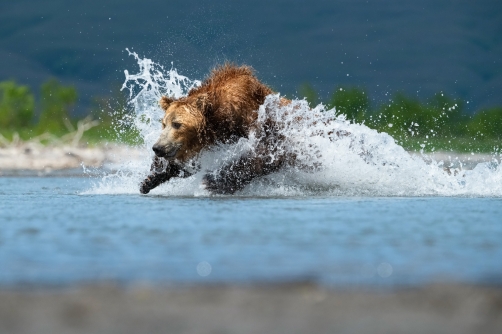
xmin=140 ymin=63 xmax=289 ymax=194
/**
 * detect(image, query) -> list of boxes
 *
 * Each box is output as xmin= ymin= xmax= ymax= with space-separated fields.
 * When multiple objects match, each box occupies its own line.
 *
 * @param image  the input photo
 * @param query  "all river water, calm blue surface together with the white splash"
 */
xmin=0 ymin=53 xmax=502 ymax=286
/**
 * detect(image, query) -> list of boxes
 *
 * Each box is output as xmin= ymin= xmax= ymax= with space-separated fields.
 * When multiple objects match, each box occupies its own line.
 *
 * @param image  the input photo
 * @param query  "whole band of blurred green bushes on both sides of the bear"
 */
xmin=0 ymin=79 xmax=502 ymax=152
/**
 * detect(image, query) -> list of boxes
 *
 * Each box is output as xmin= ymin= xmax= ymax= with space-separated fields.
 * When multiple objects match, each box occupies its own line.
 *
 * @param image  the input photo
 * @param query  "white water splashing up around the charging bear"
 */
xmin=88 ymin=50 xmax=502 ymax=196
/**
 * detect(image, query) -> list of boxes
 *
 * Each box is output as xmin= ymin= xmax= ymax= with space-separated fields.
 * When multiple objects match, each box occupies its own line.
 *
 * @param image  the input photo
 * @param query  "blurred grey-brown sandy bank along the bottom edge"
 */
xmin=0 ymin=284 xmax=502 ymax=334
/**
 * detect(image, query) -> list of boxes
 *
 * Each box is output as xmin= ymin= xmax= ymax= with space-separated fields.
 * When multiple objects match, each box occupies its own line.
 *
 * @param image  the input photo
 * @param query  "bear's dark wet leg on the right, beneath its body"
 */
xmin=202 ymin=154 xmax=284 ymax=194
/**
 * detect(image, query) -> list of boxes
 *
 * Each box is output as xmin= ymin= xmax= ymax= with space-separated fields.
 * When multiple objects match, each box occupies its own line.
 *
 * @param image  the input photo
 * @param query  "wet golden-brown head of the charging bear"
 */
xmin=152 ymin=94 xmax=210 ymax=162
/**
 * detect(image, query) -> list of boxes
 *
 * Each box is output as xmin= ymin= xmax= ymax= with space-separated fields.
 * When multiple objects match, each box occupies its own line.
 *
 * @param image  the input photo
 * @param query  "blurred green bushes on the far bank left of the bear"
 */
xmin=0 ymin=79 xmax=139 ymax=143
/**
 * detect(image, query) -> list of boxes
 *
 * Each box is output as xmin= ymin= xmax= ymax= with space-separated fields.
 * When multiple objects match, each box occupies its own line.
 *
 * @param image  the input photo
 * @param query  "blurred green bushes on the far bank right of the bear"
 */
xmin=299 ymin=84 xmax=502 ymax=152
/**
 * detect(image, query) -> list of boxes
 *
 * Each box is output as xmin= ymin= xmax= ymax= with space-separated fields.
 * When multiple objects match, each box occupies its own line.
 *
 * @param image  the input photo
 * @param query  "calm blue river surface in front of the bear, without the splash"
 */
xmin=0 ymin=176 xmax=502 ymax=286
